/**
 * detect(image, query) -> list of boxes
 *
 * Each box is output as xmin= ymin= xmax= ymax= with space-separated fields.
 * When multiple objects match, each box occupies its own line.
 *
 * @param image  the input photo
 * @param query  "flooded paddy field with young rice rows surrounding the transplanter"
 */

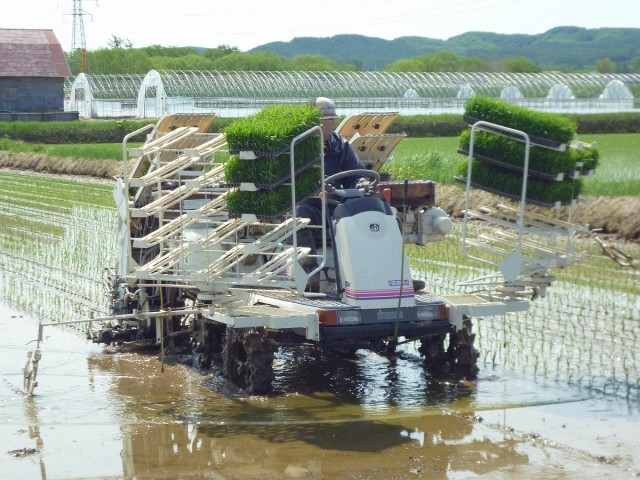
xmin=0 ymin=171 xmax=640 ymax=479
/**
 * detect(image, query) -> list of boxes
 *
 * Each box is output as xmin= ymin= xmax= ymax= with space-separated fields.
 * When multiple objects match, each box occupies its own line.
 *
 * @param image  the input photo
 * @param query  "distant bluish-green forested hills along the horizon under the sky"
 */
xmin=249 ymin=27 xmax=640 ymax=71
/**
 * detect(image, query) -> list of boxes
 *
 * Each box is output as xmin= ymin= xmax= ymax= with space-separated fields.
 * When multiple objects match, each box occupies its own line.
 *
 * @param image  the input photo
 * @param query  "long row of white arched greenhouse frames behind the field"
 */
xmin=65 ymin=70 xmax=640 ymax=118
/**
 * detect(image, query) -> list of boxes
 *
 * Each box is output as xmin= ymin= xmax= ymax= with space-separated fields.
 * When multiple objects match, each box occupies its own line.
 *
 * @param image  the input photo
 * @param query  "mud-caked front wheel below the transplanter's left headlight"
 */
xmin=223 ymin=327 xmax=274 ymax=394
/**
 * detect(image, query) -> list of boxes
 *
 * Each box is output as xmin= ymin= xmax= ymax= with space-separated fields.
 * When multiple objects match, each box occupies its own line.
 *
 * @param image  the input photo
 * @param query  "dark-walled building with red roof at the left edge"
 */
xmin=0 ymin=29 xmax=76 ymax=120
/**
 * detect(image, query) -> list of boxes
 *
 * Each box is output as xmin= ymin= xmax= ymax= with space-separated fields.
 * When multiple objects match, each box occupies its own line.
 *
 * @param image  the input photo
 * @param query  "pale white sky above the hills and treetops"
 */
xmin=5 ymin=0 xmax=640 ymax=52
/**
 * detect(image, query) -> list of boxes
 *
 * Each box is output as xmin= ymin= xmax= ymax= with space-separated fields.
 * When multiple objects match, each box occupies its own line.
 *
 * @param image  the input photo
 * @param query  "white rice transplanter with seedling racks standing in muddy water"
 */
xmin=25 ymin=100 xmax=596 ymax=393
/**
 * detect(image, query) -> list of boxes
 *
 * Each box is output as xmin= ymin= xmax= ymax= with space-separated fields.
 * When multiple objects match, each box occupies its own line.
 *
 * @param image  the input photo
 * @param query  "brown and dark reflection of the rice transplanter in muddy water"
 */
xmin=77 ymin=344 xmax=528 ymax=479
